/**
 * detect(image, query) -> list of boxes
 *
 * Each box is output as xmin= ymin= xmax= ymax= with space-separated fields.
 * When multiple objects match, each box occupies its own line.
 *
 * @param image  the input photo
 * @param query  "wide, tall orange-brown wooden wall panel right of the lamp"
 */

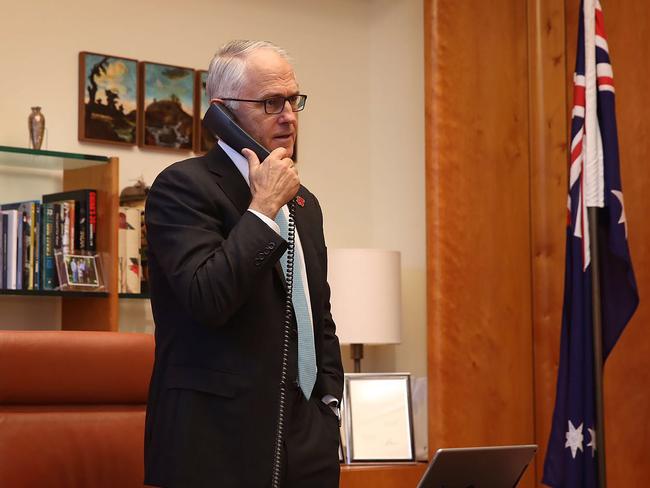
xmin=425 ymin=0 xmax=533 ymax=486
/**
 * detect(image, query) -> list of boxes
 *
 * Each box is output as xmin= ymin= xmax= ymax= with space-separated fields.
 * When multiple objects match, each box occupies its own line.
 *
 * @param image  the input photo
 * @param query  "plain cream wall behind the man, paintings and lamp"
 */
xmin=0 ymin=0 xmax=426 ymax=375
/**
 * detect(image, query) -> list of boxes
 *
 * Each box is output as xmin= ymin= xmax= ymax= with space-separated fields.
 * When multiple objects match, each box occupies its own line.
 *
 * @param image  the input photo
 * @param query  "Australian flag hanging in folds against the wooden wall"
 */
xmin=543 ymin=0 xmax=639 ymax=488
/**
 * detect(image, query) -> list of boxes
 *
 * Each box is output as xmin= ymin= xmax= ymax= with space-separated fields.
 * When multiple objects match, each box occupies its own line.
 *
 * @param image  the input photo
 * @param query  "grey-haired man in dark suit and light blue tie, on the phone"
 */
xmin=145 ymin=41 xmax=343 ymax=488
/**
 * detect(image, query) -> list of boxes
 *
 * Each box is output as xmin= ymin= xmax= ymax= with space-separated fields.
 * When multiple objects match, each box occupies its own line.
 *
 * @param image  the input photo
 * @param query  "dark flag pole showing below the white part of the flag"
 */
xmin=587 ymin=207 xmax=607 ymax=488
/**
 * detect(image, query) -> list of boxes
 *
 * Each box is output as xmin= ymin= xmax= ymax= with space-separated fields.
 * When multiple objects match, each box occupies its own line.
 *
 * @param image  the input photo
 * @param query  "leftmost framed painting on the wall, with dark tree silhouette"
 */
xmin=78 ymin=51 xmax=138 ymax=145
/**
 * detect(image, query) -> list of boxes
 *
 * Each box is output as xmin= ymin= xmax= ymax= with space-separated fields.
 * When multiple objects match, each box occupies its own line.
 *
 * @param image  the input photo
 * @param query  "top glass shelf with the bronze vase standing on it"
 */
xmin=0 ymin=146 xmax=110 ymax=170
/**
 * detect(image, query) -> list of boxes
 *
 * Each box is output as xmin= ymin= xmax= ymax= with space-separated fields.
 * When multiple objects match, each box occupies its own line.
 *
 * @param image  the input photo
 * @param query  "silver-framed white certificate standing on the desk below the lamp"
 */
xmin=344 ymin=373 xmax=415 ymax=463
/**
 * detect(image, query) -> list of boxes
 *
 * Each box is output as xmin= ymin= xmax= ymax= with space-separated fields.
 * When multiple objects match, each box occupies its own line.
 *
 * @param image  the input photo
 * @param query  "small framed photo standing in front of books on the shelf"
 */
xmin=54 ymin=252 xmax=105 ymax=291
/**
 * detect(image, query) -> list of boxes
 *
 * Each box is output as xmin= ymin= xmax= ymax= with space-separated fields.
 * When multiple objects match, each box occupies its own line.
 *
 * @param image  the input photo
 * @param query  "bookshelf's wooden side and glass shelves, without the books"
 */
xmin=0 ymin=146 xmax=119 ymax=331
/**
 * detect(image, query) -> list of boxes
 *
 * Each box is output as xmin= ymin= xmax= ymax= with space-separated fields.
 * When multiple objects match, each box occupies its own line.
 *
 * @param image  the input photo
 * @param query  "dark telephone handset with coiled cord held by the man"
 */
xmin=203 ymin=103 xmax=296 ymax=488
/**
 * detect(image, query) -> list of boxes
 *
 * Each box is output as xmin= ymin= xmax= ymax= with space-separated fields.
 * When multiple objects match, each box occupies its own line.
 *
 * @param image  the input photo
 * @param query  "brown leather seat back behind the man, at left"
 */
xmin=0 ymin=331 xmax=154 ymax=488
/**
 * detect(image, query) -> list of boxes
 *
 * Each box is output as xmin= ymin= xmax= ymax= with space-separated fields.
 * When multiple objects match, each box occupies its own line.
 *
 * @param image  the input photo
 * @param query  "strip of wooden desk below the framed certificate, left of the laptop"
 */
xmin=339 ymin=463 xmax=427 ymax=488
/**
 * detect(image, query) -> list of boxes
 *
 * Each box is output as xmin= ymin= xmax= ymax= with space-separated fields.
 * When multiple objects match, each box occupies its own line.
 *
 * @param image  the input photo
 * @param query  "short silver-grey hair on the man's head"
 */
xmin=205 ymin=40 xmax=291 ymax=109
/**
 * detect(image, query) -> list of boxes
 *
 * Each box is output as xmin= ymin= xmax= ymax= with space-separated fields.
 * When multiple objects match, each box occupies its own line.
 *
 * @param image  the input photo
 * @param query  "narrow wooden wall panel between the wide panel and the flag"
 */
xmin=528 ymin=0 xmax=570 ymax=486
